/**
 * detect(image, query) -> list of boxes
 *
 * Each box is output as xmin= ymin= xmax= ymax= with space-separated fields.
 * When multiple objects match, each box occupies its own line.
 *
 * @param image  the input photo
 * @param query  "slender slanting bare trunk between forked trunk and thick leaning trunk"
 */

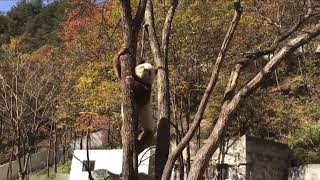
xmin=161 ymin=4 xmax=241 ymax=180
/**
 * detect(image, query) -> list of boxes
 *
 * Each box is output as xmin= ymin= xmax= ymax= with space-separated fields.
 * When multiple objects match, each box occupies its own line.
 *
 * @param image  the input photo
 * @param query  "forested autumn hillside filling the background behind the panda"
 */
xmin=0 ymin=0 xmax=320 ymax=179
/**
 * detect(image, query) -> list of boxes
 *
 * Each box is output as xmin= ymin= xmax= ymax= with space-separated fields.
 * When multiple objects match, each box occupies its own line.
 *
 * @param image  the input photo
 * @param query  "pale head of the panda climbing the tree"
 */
xmin=135 ymin=63 xmax=157 ymax=84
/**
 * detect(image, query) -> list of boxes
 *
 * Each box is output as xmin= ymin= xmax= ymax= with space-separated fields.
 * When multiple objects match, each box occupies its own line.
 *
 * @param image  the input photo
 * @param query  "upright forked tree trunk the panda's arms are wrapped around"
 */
xmin=120 ymin=0 xmax=147 ymax=180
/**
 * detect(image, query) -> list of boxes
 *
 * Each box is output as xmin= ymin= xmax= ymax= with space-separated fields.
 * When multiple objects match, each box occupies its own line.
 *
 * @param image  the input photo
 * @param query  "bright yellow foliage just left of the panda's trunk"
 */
xmin=71 ymin=62 xmax=121 ymax=114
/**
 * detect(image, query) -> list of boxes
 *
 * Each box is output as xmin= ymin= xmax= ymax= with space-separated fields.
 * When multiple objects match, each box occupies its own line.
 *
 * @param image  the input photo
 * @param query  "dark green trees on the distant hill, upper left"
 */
xmin=0 ymin=0 xmax=66 ymax=52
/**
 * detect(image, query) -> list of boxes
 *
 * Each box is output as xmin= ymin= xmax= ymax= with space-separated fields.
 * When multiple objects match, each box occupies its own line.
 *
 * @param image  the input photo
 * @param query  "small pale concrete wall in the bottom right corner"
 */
xmin=288 ymin=164 xmax=320 ymax=180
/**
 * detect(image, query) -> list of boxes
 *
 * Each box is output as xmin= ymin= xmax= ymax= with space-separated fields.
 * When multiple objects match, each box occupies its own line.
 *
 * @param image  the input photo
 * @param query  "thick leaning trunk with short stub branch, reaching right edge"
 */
xmin=188 ymin=23 xmax=320 ymax=180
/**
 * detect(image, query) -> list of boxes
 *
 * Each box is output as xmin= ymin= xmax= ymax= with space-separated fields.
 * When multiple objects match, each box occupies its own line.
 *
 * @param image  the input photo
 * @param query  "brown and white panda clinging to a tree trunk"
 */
xmin=113 ymin=46 xmax=157 ymax=153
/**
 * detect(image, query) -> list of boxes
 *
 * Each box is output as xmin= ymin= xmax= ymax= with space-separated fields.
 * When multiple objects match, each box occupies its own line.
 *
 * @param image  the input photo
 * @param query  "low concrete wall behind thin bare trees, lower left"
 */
xmin=0 ymin=151 xmax=62 ymax=180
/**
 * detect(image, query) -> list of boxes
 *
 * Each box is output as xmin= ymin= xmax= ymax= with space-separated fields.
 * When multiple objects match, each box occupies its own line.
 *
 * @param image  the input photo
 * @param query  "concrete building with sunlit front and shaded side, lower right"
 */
xmin=196 ymin=136 xmax=289 ymax=180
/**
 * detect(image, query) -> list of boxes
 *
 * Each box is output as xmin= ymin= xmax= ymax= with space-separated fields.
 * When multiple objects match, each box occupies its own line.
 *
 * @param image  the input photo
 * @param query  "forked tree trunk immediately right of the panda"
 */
xmin=145 ymin=0 xmax=178 ymax=177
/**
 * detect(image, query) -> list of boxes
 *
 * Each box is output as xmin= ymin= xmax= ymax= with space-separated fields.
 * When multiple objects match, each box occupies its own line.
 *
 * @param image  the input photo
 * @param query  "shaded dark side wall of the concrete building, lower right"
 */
xmin=246 ymin=136 xmax=289 ymax=180
